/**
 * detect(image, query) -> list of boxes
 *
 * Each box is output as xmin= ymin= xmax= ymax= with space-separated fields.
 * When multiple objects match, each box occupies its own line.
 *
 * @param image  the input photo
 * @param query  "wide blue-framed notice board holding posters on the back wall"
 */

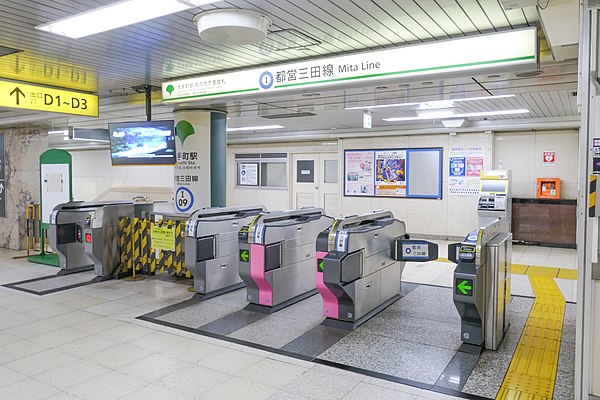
xmin=344 ymin=147 xmax=443 ymax=199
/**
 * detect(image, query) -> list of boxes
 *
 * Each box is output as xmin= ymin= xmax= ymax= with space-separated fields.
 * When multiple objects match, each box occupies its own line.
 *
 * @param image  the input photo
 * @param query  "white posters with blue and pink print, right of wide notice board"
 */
xmin=448 ymin=147 xmax=484 ymax=196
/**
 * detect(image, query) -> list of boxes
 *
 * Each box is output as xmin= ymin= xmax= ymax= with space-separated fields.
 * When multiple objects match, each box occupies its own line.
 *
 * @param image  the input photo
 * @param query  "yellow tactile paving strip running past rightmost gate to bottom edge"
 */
xmin=496 ymin=275 xmax=566 ymax=400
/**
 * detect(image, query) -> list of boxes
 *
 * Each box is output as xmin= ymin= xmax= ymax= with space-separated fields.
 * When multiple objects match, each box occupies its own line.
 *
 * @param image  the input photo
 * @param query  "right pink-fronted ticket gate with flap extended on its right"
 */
xmin=316 ymin=211 xmax=438 ymax=329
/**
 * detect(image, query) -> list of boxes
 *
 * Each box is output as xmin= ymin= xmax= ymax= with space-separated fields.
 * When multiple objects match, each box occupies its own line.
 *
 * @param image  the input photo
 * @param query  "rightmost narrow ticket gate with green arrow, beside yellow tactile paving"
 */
xmin=448 ymin=219 xmax=512 ymax=353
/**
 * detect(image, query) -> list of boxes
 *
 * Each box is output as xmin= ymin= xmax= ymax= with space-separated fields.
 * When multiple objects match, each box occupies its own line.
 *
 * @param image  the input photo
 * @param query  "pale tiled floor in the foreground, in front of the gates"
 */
xmin=0 ymin=250 xmax=466 ymax=400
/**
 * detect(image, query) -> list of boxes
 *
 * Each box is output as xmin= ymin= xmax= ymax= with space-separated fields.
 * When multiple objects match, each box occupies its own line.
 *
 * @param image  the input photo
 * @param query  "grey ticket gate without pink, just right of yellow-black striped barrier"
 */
xmin=185 ymin=206 xmax=266 ymax=300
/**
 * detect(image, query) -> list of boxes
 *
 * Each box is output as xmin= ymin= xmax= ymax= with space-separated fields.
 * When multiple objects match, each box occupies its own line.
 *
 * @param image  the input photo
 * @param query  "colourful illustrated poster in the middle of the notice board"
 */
xmin=375 ymin=150 xmax=406 ymax=197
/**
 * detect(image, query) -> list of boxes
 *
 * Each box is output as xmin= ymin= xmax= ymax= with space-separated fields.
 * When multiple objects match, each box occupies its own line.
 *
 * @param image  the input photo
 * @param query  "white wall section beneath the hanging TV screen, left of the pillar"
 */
xmin=70 ymin=149 xmax=173 ymax=201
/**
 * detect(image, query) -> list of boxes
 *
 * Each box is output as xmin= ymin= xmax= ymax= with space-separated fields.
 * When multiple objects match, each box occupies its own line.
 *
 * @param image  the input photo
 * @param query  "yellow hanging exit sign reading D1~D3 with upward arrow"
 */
xmin=0 ymin=81 xmax=98 ymax=117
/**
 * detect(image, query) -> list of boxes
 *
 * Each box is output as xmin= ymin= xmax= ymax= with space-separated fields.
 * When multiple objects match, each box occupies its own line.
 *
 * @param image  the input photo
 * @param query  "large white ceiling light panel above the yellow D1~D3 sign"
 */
xmin=35 ymin=0 xmax=214 ymax=39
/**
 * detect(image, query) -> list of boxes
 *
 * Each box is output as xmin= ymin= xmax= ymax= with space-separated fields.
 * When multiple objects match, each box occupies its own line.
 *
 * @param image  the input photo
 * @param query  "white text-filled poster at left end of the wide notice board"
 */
xmin=344 ymin=150 xmax=375 ymax=196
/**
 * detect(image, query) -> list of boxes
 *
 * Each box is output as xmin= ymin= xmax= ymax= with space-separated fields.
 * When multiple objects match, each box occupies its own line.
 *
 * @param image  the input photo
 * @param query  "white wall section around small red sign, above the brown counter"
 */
xmin=494 ymin=131 xmax=579 ymax=200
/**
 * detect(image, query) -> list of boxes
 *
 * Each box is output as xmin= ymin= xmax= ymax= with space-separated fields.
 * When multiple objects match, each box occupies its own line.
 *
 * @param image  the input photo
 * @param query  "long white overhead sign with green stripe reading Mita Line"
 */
xmin=162 ymin=27 xmax=537 ymax=103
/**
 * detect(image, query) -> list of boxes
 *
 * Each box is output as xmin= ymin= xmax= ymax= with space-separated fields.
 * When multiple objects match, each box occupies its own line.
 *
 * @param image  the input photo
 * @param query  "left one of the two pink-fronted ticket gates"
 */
xmin=238 ymin=207 xmax=333 ymax=313
